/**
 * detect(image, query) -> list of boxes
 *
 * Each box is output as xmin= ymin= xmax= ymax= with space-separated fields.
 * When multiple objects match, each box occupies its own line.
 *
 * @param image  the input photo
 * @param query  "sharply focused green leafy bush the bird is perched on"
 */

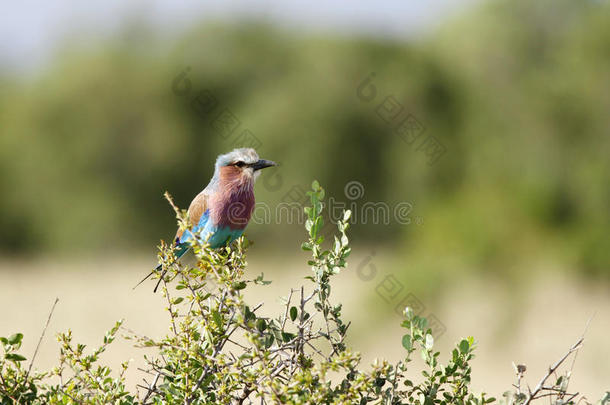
xmin=0 ymin=182 xmax=607 ymax=405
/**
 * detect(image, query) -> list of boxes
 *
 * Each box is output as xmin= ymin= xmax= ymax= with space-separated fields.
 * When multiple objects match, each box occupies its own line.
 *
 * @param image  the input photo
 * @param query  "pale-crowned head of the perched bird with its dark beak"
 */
xmin=215 ymin=148 xmax=277 ymax=181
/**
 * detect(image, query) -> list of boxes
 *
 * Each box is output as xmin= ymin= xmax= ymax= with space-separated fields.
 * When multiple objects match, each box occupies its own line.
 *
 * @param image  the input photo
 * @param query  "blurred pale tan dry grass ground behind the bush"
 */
xmin=0 ymin=253 xmax=610 ymax=401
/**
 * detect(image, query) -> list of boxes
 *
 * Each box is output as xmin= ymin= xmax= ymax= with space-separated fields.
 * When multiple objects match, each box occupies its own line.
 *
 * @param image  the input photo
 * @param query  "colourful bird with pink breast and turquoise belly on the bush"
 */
xmin=134 ymin=148 xmax=277 ymax=292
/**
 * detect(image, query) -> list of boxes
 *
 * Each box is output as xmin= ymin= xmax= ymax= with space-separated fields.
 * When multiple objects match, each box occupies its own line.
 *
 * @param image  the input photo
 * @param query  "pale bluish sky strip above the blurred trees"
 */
xmin=0 ymin=0 xmax=477 ymax=70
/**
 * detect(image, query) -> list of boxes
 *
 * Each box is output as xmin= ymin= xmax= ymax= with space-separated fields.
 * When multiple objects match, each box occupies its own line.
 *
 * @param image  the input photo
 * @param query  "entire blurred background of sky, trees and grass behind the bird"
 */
xmin=0 ymin=0 xmax=610 ymax=400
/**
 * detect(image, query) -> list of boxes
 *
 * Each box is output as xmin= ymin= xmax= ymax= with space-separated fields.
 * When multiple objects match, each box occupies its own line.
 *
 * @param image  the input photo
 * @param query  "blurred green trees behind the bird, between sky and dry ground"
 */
xmin=0 ymin=0 xmax=610 ymax=284
